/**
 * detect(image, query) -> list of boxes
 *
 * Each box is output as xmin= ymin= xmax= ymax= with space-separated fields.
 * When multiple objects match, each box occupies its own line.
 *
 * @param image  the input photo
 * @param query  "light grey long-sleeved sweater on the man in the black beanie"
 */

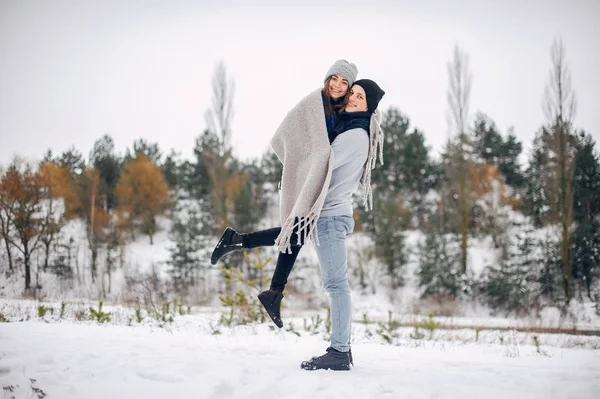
xmin=320 ymin=129 xmax=369 ymax=216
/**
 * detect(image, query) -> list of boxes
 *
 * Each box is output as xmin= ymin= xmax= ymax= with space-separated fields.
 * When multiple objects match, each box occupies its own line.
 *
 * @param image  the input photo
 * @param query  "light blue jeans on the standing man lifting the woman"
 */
xmin=315 ymin=215 xmax=354 ymax=352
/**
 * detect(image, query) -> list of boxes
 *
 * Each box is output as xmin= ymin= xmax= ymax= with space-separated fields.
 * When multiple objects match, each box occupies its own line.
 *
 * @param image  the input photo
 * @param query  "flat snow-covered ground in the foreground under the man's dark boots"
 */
xmin=0 ymin=308 xmax=600 ymax=399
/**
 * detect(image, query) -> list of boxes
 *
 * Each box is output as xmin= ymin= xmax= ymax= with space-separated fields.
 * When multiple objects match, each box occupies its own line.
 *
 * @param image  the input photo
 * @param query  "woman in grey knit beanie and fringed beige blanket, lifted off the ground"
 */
xmin=211 ymin=60 xmax=358 ymax=328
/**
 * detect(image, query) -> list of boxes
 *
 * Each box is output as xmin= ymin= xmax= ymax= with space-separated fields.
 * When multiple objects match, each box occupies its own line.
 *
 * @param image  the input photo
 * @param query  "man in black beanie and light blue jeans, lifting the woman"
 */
xmin=301 ymin=79 xmax=385 ymax=370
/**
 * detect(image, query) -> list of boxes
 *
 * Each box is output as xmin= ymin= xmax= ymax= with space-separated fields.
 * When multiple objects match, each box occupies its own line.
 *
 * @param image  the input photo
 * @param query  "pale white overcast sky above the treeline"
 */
xmin=0 ymin=0 xmax=600 ymax=165
